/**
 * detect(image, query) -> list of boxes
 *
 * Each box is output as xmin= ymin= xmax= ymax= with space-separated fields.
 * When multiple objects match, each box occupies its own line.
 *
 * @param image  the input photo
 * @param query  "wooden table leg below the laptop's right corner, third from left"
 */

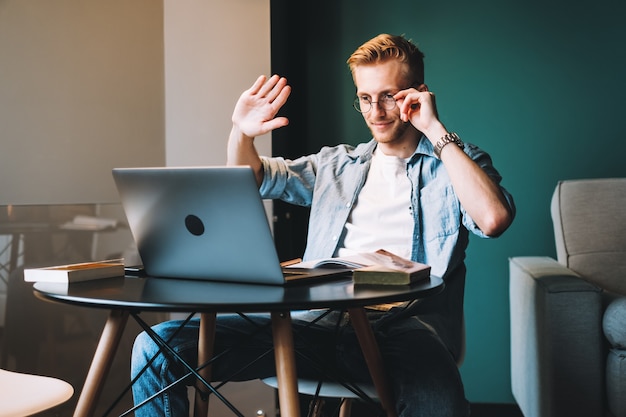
xmin=272 ymin=311 xmax=300 ymax=417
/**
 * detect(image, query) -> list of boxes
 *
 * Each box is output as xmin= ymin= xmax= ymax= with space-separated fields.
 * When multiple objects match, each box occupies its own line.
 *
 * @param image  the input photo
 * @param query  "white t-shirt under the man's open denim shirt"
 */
xmin=336 ymin=149 xmax=413 ymax=259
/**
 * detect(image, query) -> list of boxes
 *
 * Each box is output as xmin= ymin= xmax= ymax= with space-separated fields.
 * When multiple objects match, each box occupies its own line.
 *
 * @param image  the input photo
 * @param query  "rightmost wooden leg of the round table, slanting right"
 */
xmin=348 ymin=307 xmax=396 ymax=417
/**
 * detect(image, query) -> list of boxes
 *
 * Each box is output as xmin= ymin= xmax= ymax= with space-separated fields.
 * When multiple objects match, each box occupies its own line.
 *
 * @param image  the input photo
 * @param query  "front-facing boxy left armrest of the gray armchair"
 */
xmin=509 ymin=257 xmax=604 ymax=417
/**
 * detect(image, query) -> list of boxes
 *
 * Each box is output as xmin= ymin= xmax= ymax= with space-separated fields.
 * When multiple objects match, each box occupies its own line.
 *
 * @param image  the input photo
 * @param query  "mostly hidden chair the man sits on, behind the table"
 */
xmin=262 ymin=316 xmax=466 ymax=417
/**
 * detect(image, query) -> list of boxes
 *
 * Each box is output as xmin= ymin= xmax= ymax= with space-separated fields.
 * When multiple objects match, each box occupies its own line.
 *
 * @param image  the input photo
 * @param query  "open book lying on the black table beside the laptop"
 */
xmin=289 ymin=249 xmax=430 ymax=285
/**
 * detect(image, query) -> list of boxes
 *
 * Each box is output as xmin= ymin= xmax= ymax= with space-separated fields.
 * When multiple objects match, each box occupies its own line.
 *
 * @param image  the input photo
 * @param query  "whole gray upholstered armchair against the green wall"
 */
xmin=509 ymin=178 xmax=626 ymax=417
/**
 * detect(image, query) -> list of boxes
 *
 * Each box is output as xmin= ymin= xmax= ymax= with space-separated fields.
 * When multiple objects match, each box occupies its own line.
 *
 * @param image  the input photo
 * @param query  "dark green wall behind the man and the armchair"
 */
xmin=272 ymin=0 xmax=626 ymax=403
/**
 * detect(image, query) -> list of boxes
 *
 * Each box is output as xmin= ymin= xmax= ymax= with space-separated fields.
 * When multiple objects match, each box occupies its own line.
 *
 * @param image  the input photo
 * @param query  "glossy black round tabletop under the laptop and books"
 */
xmin=33 ymin=277 xmax=444 ymax=312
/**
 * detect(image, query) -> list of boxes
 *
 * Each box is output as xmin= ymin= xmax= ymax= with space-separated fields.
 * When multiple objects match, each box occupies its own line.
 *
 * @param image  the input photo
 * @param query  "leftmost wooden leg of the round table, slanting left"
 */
xmin=74 ymin=310 xmax=129 ymax=417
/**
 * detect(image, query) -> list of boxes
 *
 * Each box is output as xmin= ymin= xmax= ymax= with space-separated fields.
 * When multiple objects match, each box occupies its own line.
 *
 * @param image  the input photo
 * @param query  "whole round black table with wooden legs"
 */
xmin=33 ymin=276 xmax=444 ymax=416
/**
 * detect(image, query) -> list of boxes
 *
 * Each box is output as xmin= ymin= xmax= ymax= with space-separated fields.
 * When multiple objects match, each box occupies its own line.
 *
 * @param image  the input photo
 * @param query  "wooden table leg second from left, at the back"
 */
xmin=193 ymin=313 xmax=216 ymax=417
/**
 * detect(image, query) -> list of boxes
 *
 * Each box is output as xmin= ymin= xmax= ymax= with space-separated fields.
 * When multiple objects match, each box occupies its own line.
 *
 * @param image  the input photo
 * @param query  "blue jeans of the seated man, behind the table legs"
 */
xmin=131 ymin=311 xmax=469 ymax=417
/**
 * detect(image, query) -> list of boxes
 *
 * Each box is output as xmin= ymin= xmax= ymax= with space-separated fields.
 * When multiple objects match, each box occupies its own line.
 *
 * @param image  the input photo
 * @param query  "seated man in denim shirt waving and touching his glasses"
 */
xmin=132 ymin=34 xmax=515 ymax=417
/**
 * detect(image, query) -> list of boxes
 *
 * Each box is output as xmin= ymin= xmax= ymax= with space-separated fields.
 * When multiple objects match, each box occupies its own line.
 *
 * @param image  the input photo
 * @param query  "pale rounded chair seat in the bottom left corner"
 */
xmin=0 ymin=369 xmax=74 ymax=417
